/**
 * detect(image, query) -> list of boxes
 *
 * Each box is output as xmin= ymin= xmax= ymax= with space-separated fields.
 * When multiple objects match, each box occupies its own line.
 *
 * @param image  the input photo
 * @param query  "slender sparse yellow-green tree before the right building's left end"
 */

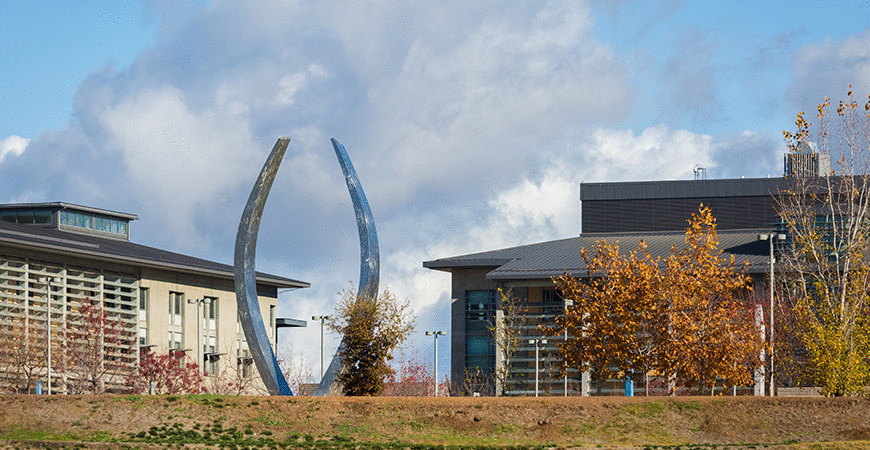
xmin=489 ymin=289 xmax=528 ymax=395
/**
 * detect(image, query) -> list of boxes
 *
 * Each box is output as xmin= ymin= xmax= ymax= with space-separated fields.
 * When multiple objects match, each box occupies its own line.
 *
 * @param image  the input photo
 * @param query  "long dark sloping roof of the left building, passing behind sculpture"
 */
xmin=0 ymin=222 xmax=310 ymax=288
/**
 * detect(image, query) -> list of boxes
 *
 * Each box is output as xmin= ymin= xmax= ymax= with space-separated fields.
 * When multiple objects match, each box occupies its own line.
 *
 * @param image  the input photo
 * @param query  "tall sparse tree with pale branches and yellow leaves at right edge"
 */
xmin=779 ymin=86 xmax=870 ymax=396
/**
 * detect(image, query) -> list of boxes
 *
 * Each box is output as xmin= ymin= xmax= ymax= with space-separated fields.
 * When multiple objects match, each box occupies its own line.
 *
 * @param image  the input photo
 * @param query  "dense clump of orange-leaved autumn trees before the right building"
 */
xmin=549 ymin=205 xmax=762 ymax=393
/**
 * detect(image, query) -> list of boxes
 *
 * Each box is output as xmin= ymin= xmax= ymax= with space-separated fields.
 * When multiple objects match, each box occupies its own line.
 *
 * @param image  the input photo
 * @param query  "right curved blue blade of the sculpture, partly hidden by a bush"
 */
xmin=314 ymin=139 xmax=381 ymax=396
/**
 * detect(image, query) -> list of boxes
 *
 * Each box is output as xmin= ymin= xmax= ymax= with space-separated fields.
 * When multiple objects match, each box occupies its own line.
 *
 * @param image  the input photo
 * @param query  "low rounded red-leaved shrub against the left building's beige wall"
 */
xmin=126 ymin=350 xmax=205 ymax=394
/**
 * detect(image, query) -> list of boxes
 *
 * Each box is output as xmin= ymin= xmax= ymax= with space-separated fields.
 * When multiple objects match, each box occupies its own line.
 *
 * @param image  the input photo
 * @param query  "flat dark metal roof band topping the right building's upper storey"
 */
xmin=580 ymin=178 xmax=794 ymax=201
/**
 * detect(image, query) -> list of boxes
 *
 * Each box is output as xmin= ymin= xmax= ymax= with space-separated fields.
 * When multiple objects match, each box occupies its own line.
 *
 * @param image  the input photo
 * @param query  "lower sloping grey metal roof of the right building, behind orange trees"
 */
xmin=423 ymin=229 xmax=770 ymax=281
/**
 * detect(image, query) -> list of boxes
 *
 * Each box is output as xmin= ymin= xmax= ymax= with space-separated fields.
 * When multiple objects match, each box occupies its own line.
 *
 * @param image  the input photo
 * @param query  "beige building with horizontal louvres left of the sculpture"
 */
xmin=0 ymin=203 xmax=309 ymax=392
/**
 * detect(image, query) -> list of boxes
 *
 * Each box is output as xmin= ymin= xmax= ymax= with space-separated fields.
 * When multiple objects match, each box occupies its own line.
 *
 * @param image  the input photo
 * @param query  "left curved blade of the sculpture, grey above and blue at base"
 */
xmin=233 ymin=138 xmax=293 ymax=395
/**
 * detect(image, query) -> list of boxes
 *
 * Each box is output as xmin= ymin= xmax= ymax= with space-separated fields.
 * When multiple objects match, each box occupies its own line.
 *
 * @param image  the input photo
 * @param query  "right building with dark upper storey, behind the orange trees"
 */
xmin=423 ymin=178 xmax=790 ymax=395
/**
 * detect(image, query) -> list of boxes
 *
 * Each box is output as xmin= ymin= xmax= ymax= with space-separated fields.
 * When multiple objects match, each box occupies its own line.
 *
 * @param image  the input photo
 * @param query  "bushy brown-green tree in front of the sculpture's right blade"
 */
xmin=329 ymin=290 xmax=415 ymax=396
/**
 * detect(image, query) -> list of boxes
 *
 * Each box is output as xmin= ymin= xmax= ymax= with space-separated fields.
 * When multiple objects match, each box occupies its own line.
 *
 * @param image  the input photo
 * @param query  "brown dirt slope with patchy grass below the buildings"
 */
xmin=0 ymin=396 xmax=870 ymax=448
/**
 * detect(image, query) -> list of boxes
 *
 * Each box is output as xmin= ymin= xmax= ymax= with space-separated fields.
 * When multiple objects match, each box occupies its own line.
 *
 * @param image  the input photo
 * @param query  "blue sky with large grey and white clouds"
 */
xmin=0 ymin=0 xmax=870 ymax=384
